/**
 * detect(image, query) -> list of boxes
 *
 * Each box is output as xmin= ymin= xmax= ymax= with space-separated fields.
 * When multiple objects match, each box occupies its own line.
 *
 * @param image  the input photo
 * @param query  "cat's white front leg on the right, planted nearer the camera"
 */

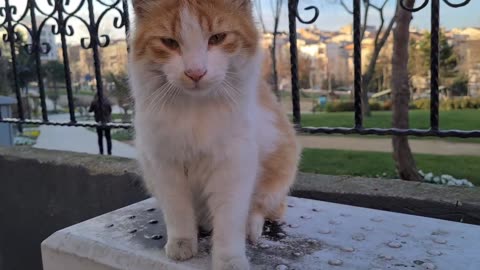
xmin=207 ymin=144 xmax=258 ymax=270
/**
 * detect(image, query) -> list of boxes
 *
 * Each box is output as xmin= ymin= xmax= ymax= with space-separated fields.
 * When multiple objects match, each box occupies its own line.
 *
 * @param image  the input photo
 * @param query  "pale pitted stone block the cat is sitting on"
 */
xmin=42 ymin=198 xmax=480 ymax=270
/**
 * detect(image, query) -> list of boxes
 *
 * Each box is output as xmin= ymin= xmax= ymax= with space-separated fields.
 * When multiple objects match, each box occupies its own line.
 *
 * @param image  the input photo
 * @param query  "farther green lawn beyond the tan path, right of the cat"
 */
xmin=302 ymin=109 xmax=480 ymax=143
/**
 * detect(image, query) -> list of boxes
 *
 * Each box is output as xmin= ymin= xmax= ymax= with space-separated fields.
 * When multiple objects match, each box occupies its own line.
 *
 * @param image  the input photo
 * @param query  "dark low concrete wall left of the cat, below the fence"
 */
xmin=0 ymin=148 xmax=147 ymax=270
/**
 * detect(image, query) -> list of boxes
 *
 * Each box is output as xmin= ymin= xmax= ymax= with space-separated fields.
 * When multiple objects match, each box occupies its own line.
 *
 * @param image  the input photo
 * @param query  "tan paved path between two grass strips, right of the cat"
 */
xmin=299 ymin=136 xmax=480 ymax=157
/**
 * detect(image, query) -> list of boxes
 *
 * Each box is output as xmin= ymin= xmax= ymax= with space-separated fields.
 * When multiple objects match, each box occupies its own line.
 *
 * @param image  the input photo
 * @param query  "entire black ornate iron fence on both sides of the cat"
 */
xmin=0 ymin=0 xmax=480 ymax=138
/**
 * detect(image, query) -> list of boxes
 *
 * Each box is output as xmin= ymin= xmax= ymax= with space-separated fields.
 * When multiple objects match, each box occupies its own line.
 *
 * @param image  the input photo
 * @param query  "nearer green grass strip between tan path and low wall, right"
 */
xmin=300 ymin=148 xmax=480 ymax=186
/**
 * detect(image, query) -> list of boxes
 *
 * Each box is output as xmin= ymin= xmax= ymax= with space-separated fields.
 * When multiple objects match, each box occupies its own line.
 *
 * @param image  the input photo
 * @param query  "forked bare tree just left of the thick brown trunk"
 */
xmin=340 ymin=0 xmax=398 ymax=116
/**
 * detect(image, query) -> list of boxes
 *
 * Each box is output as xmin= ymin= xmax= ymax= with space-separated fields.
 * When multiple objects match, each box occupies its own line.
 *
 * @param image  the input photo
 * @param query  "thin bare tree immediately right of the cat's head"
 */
xmin=255 ymin=0 xmax=284 ymax=100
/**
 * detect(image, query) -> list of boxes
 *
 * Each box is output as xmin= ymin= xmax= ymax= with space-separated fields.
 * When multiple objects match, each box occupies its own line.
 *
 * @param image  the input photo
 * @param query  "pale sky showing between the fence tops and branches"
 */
xmin=0 ymin=0 xmax=480 ymax=43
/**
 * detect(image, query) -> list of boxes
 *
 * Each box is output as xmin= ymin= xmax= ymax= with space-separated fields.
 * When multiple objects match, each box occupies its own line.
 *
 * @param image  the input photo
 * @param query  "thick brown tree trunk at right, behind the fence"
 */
xmin=392 ymin=0 xmax=422 ymax=181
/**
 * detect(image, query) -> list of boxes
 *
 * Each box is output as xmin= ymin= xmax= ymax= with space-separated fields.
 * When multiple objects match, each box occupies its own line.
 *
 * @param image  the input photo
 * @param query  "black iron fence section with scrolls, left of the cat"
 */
xmin=0 ymin=0 xmax=130 ymax=128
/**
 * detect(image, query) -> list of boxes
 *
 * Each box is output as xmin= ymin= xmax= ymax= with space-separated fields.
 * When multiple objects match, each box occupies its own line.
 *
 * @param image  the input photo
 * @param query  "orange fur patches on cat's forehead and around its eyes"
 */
xmin=133 ymin=0 xmax=258 ymax=63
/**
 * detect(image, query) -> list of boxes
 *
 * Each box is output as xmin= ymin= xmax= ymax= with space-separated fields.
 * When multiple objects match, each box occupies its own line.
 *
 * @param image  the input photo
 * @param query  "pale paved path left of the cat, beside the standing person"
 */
xmin=34 ymin=114 xmax=135 ymax=158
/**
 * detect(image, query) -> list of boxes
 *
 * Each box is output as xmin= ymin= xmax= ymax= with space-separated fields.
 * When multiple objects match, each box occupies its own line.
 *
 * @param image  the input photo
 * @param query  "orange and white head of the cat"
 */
xmin=132 ymin=0 xmax=258 ymax=95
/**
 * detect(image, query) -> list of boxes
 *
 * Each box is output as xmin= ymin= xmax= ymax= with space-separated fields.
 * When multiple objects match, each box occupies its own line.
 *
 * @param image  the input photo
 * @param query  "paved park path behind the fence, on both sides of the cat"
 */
xmin=34 ymin=114 xmax=480 ymax=158
